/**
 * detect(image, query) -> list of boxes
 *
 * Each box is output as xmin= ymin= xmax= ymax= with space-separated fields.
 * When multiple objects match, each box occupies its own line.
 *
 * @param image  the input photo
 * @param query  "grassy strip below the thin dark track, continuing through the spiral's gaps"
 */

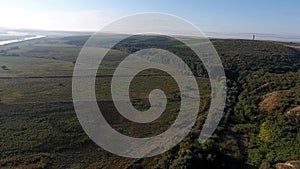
xmin=0 ymin=77 xmax=210 ymax=104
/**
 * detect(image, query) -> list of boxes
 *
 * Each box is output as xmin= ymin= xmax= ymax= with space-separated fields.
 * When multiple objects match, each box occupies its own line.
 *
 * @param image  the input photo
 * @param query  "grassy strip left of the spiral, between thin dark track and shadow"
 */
xmin=0 ymin=78 xmax=72 ymax=104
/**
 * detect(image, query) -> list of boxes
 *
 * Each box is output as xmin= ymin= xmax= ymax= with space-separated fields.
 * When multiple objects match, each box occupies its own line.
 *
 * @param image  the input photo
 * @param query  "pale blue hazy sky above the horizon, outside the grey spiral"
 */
xmin=0 ymin=0 xmax=300 ymax=35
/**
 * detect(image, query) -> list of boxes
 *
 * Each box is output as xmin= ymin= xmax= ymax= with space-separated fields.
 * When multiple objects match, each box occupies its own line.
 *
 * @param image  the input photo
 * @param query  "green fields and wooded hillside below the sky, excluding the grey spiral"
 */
xmin=0 ymin=35 xmax=300 ymax=169
